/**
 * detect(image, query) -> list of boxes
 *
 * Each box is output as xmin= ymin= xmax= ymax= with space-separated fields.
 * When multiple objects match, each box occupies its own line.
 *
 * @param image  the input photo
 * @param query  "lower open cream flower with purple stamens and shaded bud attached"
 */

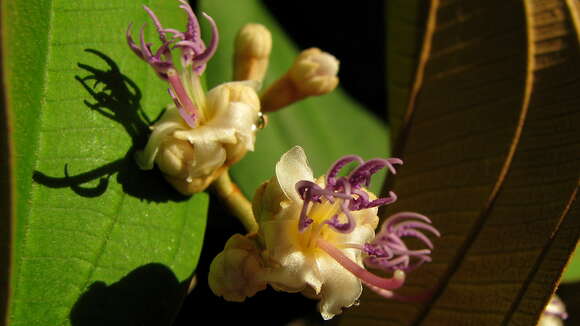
xmin=209 ymin=146 xmax=439 ymax=319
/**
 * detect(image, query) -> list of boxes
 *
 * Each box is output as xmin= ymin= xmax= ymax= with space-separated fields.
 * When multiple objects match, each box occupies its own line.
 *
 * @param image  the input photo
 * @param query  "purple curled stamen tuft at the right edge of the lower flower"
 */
xmin=363 ymin=212 xmax=440 ymax=271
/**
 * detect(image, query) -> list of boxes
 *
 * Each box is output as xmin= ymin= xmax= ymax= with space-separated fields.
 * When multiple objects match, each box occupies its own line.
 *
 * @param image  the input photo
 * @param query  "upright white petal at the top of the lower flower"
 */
xmin=276 ymin=146 xmax=314 ymax=202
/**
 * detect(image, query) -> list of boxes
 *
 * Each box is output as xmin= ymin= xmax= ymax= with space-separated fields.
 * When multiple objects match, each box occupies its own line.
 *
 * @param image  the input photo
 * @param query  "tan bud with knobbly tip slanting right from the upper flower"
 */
xmin=261 ymin=48 xmax=339 ymax=112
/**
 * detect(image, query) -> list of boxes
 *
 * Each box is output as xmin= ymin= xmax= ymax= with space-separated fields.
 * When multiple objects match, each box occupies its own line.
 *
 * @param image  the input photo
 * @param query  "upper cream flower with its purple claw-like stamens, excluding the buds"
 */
xmin=126 ymin=0 xmax=261 ymax=195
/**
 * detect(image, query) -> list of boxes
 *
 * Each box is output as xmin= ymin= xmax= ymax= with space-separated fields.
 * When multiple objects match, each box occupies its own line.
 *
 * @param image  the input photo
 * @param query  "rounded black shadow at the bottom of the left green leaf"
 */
xmin=69 ymin=263 xmax=189 ymax=326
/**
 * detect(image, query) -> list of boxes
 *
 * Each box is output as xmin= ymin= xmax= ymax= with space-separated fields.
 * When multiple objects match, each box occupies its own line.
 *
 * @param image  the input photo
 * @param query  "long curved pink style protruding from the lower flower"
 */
xmin=317 ymin=239 xmax=405 ymax=290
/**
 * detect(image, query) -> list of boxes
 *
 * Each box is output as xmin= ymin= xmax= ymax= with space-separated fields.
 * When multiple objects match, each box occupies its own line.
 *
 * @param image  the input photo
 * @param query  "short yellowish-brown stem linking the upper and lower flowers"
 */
xmin=211 ymin=170 xmax=258 ymax=234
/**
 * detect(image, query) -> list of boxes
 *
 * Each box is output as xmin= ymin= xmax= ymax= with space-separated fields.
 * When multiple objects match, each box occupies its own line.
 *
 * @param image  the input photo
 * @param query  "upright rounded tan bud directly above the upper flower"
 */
xmin=234 ymin=24 xmax=272 ymax=82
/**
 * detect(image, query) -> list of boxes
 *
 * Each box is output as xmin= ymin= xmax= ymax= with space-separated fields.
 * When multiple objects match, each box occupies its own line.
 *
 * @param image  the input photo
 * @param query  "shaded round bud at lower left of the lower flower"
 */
xmin=208 ymin=234 xmax=266 ymax=302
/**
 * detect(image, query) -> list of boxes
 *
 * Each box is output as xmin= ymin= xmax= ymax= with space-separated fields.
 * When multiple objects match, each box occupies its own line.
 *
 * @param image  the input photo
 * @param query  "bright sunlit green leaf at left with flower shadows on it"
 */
xmin=0 ymin=0 xmax=208 ymax=325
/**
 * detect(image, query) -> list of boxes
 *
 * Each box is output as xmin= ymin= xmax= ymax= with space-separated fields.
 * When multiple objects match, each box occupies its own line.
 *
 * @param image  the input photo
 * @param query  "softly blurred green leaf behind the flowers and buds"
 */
xmin=200 ymin=0 xmax=390 ymax=195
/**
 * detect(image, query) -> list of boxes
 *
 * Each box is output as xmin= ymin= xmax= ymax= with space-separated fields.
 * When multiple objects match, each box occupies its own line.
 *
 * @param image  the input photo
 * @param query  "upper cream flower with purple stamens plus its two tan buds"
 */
xmin=126 ymin=0 xmax=338 ymax=195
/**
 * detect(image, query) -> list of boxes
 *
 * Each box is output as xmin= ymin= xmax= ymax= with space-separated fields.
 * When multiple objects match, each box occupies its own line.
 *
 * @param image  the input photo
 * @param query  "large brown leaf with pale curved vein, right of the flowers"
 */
xmin=342 ymin=0 xmax=580 ymax=325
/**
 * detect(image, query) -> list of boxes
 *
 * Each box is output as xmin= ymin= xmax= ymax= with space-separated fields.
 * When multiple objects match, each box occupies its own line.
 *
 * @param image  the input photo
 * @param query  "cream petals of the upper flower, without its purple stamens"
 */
xmin=137 ymin=82 xmax=260 ymax=194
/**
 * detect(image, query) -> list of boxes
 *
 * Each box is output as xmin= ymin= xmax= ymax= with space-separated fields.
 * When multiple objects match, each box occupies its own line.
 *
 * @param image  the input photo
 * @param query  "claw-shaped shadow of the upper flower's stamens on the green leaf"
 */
xmin=32 ymin=49 xmax=188 ymax=202
